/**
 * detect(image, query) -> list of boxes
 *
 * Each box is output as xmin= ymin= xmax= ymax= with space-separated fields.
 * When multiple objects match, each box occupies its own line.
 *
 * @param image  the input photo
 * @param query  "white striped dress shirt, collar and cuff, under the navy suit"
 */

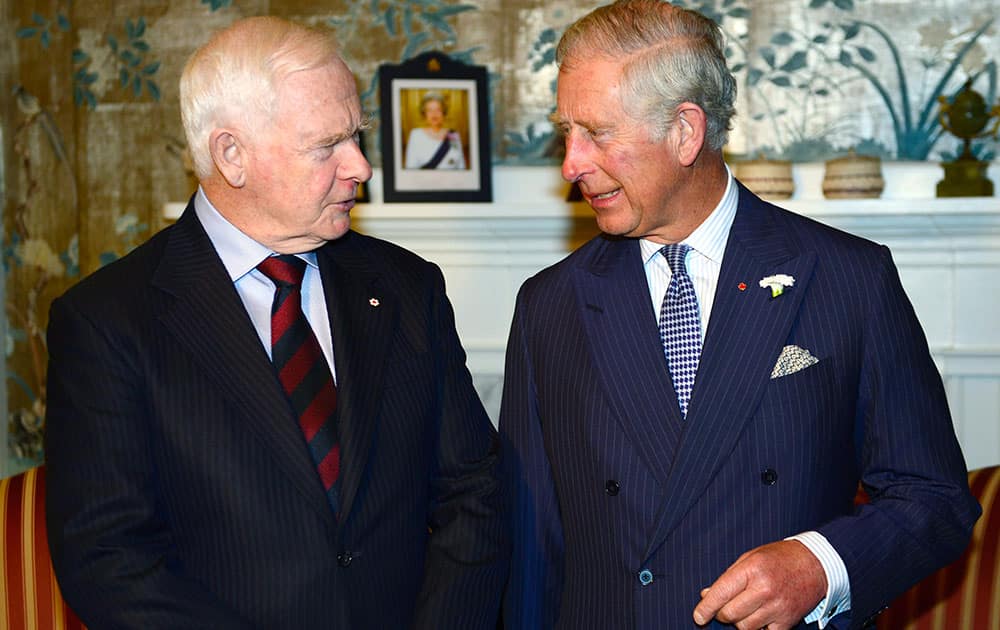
xmin=639 ymin=166 xmax=851 ymax=628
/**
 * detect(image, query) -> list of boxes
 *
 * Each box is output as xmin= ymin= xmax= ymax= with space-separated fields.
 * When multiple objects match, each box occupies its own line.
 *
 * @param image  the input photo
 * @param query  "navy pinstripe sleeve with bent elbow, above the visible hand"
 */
xmin=819 ymin=247 xmax=980 ymax=627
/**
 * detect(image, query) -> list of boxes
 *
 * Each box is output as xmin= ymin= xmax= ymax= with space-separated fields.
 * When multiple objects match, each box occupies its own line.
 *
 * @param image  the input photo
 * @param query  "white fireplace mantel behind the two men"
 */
xmin=167 ymin=162 xmax=1000 ymax=468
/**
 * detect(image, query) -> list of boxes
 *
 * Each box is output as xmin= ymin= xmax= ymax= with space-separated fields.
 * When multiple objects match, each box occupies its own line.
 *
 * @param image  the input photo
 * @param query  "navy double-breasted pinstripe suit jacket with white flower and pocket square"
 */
xmin=500 ymin=186 xmax=979 ymax=629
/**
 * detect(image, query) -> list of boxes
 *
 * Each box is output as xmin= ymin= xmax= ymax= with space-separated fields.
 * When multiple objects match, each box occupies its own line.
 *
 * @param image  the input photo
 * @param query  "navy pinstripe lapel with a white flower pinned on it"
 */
xmin=647 ymin=186 xmax=815 ymax=553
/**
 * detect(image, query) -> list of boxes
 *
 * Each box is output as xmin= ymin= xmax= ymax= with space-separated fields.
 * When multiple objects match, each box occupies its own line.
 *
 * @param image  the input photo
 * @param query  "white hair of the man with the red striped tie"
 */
xmin=180 ymin=16 xmax=343 ymax=178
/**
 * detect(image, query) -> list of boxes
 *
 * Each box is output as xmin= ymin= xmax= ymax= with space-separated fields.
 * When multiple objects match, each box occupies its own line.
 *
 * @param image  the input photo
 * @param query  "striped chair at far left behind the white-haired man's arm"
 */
xmin=0 ymin=467 xmax=84 ymax=630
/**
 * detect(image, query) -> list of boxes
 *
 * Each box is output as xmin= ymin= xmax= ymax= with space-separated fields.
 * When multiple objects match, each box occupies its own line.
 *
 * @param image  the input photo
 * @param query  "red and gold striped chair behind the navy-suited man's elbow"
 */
xmin=876 ymin=466 xmax=1000 ymax=630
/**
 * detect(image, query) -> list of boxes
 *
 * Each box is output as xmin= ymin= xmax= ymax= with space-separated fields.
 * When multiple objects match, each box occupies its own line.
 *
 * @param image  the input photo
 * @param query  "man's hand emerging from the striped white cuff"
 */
xmin=694 ymin=540 xmax=827 ymax=630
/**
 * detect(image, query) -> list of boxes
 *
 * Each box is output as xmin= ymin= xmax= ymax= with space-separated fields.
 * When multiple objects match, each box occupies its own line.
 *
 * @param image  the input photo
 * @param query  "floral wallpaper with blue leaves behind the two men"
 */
xmin=0 ymin=0 xmax=1000 ymax=473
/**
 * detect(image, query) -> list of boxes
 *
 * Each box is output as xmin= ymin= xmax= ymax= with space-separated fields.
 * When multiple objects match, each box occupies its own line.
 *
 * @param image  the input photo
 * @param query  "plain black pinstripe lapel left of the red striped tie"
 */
xmin=153 ymin=204 xmax=333 ymax=524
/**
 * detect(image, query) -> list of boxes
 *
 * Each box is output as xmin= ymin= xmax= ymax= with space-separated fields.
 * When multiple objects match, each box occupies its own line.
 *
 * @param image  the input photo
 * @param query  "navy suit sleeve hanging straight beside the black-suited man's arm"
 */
xmin=500 ymin=288 xmax=563 ymax=630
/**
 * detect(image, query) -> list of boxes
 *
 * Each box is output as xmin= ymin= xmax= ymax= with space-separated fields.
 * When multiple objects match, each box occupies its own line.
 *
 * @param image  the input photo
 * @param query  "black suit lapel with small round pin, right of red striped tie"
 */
xmin=317 ymin=233 xmax=399 ymax=522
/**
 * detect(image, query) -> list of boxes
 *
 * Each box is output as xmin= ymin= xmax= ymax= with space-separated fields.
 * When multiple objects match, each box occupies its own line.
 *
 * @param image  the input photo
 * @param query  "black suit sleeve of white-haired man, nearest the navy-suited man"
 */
xmin=414 ymin=265 xmax=510 ymax=630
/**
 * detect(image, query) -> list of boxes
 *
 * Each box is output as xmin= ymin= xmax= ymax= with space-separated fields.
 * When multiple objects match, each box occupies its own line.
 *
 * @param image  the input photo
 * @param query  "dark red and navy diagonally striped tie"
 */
xmin=257 ymin=255 xmax=340 ymax=512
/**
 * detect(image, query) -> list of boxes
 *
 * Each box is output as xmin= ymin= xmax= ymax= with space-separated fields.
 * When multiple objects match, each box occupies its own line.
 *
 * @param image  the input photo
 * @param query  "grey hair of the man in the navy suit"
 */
xmin=556 ymin=0 xmax=736 ymax=150
